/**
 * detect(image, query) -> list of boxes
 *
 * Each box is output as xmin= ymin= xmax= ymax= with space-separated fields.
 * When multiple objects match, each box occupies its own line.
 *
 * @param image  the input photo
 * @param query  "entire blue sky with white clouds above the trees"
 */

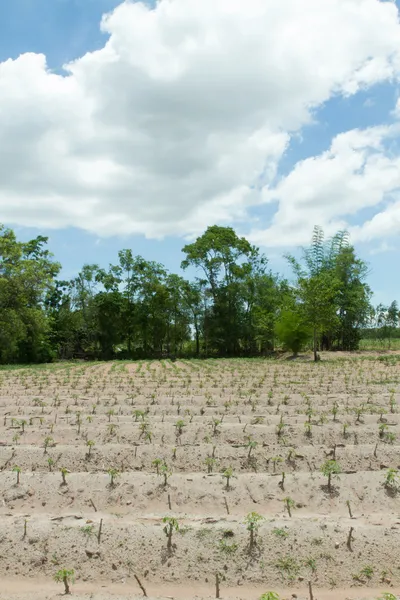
xmin=0 ymin=0 xmax=400 ymax=303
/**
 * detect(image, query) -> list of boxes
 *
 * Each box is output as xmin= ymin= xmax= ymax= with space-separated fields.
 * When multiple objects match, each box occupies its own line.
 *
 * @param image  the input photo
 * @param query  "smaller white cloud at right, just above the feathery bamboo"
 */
xmin=250 ymin=123 xmax=400 ymax=246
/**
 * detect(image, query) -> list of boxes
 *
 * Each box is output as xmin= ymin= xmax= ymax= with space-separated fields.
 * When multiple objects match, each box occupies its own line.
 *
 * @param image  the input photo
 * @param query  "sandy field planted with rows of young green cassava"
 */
xmin=0 ymin=353 xmax=400 ymax=600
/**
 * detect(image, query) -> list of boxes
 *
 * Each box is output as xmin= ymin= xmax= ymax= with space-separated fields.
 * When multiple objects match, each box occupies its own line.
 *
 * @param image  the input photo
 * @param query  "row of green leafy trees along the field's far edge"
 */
xmin=0 ymin=220 xmax=399 ymax=363
